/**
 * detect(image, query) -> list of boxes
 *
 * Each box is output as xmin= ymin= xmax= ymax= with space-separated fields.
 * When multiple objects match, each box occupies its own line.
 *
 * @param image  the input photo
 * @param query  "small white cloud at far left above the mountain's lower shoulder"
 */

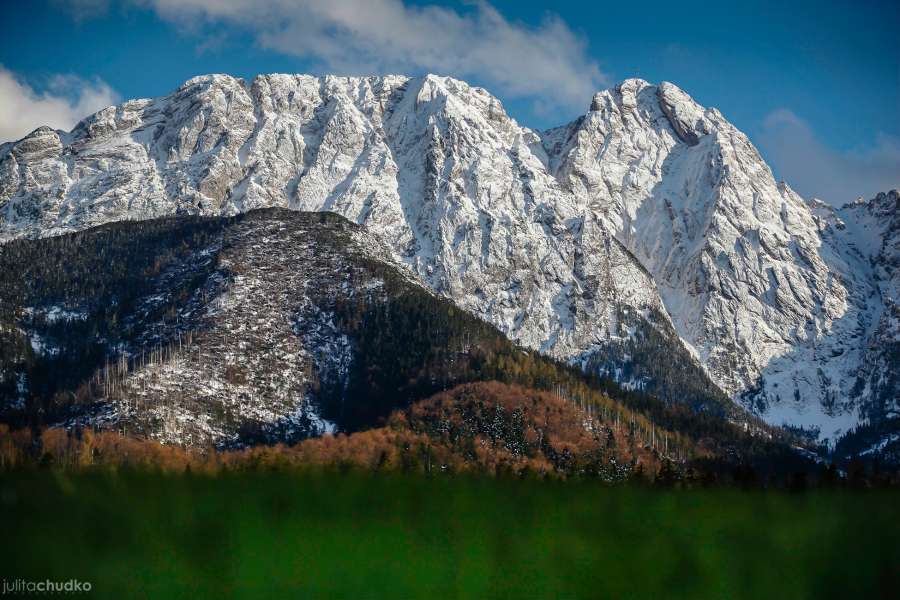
xmin=0 ymin=65 xmax=119 ymax=142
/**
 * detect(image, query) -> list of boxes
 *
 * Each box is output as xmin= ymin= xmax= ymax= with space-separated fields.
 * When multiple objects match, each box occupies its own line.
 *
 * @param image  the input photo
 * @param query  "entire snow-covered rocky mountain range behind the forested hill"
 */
xmin=0 ymin=75 xmax=900 ymax=446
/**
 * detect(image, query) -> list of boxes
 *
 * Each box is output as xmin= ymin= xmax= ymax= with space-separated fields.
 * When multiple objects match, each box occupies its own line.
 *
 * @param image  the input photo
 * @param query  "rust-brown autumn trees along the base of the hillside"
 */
xmin=0 ymin=382 xmax=676 ymax=481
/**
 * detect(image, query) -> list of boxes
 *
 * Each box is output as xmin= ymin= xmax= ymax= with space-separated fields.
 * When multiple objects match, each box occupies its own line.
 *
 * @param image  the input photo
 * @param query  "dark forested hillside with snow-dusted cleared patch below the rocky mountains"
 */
xmin=0 ymin=209 xmax=832 ymax=480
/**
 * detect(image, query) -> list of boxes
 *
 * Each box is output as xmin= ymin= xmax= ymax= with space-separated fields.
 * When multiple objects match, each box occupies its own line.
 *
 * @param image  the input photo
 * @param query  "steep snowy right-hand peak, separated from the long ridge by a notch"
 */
xmin=545 ymin=80 xmax=898 ymax=437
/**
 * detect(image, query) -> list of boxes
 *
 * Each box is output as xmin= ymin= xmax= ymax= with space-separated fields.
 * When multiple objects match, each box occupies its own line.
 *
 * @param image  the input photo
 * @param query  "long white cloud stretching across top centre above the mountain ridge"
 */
xmin=133 ymin=0 xmax=607 ymax=109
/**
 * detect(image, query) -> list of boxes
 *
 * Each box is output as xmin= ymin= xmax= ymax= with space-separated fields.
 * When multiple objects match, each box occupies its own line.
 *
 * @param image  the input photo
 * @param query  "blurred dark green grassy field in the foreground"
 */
xmin=0 ymin=471 xmax=900 ymax=600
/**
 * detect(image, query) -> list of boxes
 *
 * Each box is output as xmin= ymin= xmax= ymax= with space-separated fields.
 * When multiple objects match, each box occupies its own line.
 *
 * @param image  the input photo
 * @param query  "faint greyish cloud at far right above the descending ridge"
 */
xmin=759 ymin=108 xmax=900 ymax=206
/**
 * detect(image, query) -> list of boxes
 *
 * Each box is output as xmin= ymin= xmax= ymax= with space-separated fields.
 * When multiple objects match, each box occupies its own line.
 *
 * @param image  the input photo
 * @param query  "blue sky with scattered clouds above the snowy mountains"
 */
xmin=0 ymin=0 xmax=900 ymax=203
